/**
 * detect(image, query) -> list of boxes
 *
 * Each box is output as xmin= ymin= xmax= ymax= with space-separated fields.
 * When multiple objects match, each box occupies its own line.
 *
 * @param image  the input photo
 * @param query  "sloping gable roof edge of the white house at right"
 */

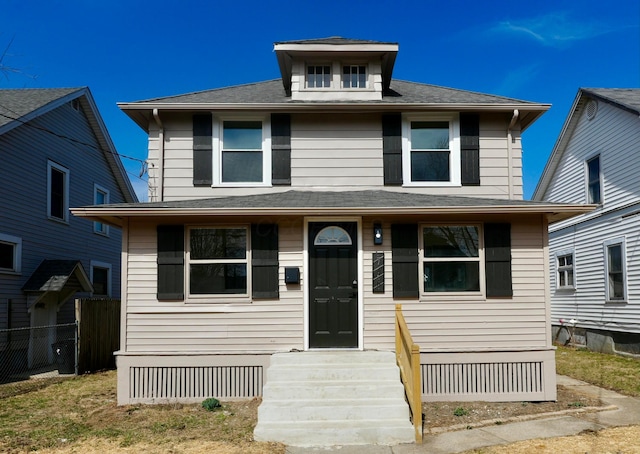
xmin=532 ymin=88 xmax=640 ymax=201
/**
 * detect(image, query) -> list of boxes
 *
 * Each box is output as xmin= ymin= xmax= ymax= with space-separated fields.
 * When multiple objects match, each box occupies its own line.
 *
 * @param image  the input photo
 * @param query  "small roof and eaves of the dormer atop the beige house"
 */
xmin=273 ymin=36 xmax=398 ymax=95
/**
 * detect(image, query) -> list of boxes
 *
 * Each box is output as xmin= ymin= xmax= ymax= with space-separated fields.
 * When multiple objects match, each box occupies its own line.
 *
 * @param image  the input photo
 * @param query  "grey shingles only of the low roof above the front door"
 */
xmin=97 ymin=190 xmax=560 ymax=210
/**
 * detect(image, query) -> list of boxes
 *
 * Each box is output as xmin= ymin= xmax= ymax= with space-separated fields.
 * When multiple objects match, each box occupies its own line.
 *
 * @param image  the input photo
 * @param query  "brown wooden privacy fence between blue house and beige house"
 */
xmin=76 ymin=298 xmax=120 ymax=374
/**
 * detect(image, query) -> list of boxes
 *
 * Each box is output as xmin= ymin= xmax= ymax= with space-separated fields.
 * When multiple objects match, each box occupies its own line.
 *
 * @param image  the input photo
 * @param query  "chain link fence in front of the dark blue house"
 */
xmin=0 ymin=323 xmax=78 ymax=399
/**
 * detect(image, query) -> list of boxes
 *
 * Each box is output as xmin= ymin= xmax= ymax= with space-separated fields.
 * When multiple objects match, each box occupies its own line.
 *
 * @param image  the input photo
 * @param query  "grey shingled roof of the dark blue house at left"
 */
xmin=0 ymin=88 xmax=82 ymax=127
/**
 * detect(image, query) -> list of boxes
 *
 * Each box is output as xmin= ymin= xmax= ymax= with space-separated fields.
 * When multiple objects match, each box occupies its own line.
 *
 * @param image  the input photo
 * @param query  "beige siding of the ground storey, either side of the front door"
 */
xmin=126 ymin=216 xmax=550 ymax=353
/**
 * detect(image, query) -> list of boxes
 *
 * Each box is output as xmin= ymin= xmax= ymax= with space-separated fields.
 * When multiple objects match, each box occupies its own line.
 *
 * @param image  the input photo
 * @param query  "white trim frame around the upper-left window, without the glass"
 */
xmin=212 ymin=115 xmax=272 ymax=188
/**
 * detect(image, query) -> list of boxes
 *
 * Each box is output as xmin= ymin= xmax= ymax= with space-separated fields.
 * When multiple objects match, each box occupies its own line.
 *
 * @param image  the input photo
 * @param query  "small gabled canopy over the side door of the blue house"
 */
xmin=22 ymin=260 xmax=93 ymax=312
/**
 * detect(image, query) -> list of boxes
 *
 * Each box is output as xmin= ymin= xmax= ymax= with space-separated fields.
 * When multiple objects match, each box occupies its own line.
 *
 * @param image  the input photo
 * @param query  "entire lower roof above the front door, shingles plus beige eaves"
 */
xmin=71 ymin=190 xmax=596 ymax=226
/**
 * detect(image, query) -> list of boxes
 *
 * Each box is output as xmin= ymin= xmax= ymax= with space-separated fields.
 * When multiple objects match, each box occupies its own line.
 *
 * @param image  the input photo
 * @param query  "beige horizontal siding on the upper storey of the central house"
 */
xmin=149 ymin=113 xmax=523 ymax=200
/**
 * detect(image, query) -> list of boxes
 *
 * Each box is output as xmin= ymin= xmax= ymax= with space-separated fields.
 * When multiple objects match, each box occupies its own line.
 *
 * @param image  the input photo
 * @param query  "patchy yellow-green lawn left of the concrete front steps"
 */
xmin=0 ymin=371 xmax=284 ymax=453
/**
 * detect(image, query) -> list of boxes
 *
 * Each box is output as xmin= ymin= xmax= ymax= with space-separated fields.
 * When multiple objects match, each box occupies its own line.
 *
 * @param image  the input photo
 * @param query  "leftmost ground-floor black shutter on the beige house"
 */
xmin=157 ymin=225 xmax=184 ymax=300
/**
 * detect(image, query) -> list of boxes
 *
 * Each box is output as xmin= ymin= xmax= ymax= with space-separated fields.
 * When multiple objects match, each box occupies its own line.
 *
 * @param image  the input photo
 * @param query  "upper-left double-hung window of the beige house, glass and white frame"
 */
xmin=217 ymin=120 xmax=271 ymax=185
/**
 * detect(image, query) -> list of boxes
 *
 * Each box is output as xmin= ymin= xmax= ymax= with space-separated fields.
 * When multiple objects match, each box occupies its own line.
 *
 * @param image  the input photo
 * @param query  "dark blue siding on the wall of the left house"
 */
xmin=0 ymin=105 xmax=124 ymax=328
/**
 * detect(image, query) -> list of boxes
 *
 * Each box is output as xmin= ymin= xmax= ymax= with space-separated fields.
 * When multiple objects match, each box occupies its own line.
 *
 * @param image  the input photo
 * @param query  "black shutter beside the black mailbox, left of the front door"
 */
xmin=251 ymin=224 xmax=279 ymax=298
